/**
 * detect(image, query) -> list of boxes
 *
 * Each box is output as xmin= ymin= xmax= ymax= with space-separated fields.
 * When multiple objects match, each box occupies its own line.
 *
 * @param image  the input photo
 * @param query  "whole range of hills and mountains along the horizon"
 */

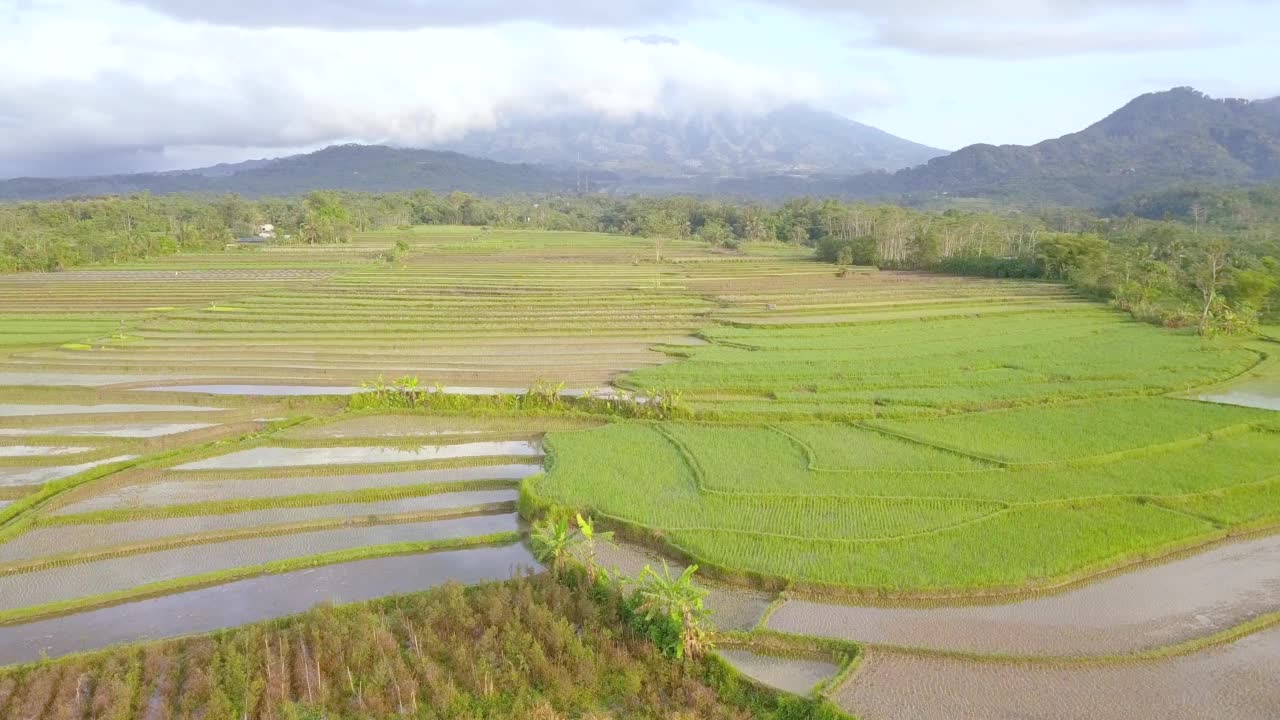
xmin=0 ymin=87 xmax=1280 ymax=208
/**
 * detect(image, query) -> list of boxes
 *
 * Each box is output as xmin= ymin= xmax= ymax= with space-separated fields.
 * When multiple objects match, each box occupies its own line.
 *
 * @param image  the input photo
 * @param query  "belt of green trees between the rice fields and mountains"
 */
xmin=0 ymin=186 xmax=1280 ymax=332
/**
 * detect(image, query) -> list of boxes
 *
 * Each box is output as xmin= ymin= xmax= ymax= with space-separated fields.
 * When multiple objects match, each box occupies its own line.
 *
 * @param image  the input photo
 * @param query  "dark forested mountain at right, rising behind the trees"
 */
xmin=865 ymin=87 xmax=1280 ymax=206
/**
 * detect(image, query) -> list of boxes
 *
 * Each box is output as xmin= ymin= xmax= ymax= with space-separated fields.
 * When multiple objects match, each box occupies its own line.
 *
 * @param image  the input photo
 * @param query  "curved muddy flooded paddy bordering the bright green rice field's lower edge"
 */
xmin=768 ymin=527 xmax=1280 ymax=657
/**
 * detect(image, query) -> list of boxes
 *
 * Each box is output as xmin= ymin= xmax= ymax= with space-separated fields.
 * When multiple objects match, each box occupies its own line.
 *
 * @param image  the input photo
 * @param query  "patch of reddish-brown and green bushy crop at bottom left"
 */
xmin=0 ymin=578 xmax=845 ymax=720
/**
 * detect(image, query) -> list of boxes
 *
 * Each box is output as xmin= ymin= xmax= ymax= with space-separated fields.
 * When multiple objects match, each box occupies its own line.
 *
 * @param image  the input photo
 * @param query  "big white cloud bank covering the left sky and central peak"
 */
xmin=0 ymin=3 xmax=820 ymax=174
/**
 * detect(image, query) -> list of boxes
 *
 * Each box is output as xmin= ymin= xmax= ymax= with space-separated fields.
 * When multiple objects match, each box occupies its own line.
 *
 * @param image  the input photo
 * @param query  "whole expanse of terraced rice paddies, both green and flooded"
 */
xmin=0 ymin=228 xmax=1280 ymax=720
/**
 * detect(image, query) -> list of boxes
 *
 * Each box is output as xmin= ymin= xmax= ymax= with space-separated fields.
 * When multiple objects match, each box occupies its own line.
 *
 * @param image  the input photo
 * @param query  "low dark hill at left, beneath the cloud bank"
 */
xmin=0 ymin=145 xmax=593 ymax=200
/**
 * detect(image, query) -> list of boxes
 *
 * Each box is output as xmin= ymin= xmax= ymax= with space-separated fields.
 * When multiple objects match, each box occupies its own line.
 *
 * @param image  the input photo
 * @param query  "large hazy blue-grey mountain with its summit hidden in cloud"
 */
xmin=443 ymin=105 xmax=946 ymax=178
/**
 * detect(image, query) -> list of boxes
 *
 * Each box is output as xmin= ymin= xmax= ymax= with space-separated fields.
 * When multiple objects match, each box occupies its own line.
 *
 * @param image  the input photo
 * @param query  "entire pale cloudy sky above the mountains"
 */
xmin=0 ymin=0 xmax=1280 ymax=177
